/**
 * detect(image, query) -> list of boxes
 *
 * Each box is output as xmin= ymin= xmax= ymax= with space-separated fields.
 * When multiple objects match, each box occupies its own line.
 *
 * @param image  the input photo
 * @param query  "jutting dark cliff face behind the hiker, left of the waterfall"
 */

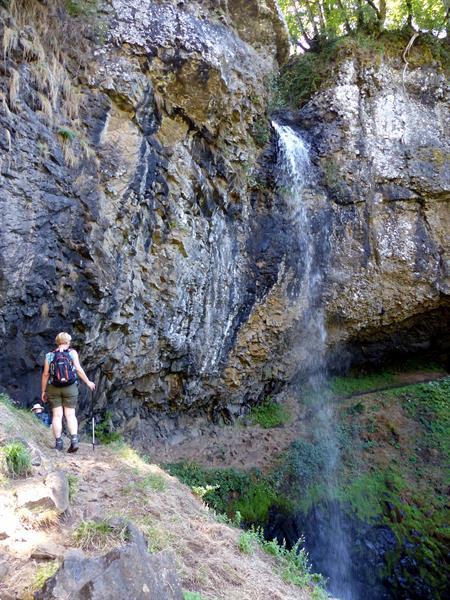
xmin=1 ymin=0 xmax=288 ymax=434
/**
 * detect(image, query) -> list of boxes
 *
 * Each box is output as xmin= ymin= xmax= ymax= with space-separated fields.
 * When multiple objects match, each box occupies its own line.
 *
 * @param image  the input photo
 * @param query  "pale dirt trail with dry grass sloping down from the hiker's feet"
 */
xmin=0 ymin=418 xmax=310 ymax=600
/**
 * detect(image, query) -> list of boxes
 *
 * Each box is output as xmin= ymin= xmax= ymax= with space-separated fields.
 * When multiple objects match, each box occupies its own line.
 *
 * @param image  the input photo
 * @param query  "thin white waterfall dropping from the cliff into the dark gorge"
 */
xmin=273 ymin=122 xmax=357 ymax=600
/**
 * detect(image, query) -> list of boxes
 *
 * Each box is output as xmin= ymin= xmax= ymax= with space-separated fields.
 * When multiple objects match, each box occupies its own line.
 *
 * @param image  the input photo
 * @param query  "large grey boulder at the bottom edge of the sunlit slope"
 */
xmin=35 ymin=526 xmax=183 ymax=600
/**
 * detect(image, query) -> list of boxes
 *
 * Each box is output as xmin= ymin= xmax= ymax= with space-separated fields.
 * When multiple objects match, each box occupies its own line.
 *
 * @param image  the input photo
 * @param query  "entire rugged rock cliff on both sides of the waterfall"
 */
xmin=0 ymin=0 xmax=449 ymax=436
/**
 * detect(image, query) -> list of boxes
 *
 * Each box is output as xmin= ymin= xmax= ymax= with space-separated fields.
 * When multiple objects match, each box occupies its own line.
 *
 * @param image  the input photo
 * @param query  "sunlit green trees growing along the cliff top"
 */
xmin=279 ymin=0 xmax=450 ymax=50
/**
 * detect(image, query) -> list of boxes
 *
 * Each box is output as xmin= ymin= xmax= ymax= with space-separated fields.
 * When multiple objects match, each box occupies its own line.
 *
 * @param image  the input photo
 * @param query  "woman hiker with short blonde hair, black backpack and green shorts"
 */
xmin=41 ymin=332 xmax=95 ymax=452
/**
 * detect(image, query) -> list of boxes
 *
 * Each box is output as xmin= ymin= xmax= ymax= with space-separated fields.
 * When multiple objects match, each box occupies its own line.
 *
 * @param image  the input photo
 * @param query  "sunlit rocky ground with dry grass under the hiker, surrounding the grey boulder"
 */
xmin=0 ymin=403 xmax=309 ymax=600
